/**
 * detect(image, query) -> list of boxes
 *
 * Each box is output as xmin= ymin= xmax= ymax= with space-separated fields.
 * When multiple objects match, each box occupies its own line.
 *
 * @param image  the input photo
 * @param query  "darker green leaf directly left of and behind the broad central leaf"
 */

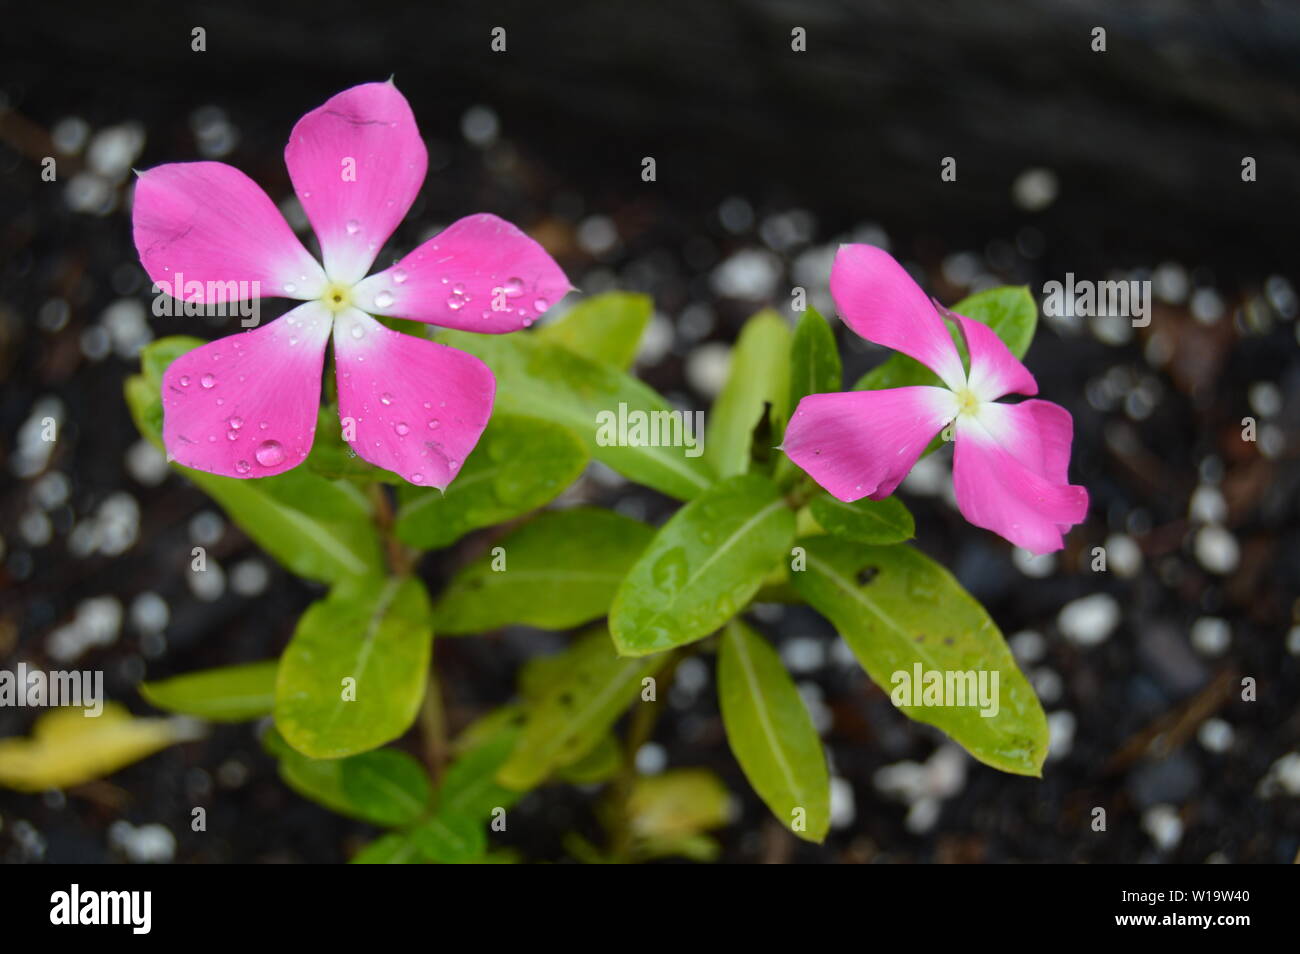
xmin=434 ymin=507 xmax=654 ymax=636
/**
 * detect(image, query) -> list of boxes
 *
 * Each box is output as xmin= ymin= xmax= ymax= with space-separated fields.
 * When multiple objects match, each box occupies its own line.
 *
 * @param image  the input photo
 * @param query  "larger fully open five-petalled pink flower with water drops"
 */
xmin=134 ymin=83 xmax=571 ymax=487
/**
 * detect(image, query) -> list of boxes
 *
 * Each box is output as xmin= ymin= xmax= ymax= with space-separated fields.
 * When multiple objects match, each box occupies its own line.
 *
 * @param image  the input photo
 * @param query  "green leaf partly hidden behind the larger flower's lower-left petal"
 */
xmin=125 ymin=338 xmax=384 ymax=582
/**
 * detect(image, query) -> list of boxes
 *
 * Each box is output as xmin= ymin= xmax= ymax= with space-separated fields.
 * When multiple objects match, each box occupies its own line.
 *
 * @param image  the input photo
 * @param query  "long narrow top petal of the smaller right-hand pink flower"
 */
xmin=831 ymin=246 xmax=966 ymax=390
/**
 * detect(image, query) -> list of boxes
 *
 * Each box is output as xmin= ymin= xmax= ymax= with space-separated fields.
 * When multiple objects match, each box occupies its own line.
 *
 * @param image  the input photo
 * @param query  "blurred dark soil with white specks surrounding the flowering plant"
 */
xmin=0 ymin=0 xmax=1300 ymax=863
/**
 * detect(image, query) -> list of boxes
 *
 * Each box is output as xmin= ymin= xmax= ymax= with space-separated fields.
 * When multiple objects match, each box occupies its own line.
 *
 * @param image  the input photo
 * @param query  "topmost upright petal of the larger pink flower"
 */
xmin=285 ymin=83 xmax=429 ymax=285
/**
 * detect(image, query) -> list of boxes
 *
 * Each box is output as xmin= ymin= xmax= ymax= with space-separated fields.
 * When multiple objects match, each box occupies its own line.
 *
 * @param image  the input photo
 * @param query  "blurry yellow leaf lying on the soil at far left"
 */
xmin=0 ymin=702 xmax=200 ymax=792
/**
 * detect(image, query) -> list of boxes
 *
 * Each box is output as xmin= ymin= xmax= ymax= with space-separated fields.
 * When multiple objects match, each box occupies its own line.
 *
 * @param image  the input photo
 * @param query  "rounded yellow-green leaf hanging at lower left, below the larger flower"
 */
xmin=276 ymin=578 xmax=433 ymax=759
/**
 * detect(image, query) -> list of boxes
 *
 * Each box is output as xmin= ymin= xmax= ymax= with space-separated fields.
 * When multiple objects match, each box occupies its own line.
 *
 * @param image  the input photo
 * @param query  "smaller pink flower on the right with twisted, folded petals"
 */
xmin=785 ymin=246 xmax=1088 ymax=554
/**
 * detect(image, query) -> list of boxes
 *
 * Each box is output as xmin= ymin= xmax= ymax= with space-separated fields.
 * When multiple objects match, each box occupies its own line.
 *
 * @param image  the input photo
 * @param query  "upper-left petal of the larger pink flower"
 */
xmin=131 ymin=162 xmax=325 ymax=304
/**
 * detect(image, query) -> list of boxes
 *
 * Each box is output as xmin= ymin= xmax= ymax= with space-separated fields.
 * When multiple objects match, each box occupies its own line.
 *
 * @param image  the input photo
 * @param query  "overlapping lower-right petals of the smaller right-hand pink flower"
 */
xmin=953 ymin=413 xmax=1088 ymax=554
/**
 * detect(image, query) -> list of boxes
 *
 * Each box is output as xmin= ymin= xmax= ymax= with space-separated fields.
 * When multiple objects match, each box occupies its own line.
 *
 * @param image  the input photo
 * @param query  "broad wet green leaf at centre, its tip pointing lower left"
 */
xmin=610 ymin=474 xmax=794 ymax=656
